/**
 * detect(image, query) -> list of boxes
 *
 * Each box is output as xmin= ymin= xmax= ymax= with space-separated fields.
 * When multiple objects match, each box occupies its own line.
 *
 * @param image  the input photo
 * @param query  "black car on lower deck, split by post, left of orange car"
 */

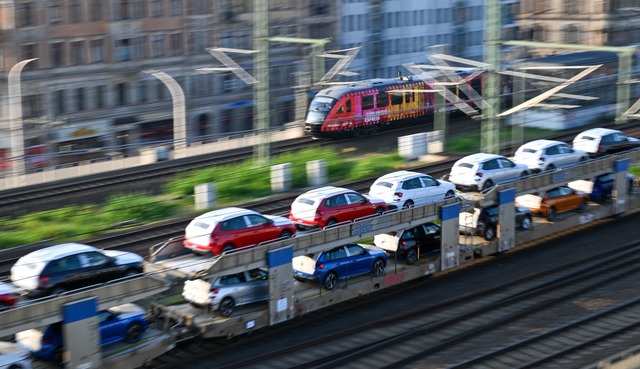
xmin=459 ymin=205 xmax=532 ymax=241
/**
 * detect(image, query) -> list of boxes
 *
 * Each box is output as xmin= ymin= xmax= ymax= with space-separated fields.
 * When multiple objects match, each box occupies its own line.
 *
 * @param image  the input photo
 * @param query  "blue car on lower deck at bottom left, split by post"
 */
xmin=16 ymin=304 xmax=149 ymax=363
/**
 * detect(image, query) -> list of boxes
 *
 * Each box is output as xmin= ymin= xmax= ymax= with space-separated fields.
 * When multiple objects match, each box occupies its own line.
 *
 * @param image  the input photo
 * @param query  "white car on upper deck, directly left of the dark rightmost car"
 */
xmin=513 ymin=140 xmax=589 ymax=172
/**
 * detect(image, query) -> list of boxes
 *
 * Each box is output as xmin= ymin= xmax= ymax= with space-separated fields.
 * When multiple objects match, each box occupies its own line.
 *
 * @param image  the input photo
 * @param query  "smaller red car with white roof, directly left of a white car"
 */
xmin=289 ymin=186 xmax=387 ymax=229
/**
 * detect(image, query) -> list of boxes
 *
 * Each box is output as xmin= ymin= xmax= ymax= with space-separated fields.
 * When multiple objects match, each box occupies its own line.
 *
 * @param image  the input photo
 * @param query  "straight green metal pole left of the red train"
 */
xmin=253 ymin=0 xmax=270 ymax=165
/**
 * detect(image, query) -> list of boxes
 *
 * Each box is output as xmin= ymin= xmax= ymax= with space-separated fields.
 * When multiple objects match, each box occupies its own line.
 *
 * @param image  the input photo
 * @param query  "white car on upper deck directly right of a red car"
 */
xmin=369 ymin=170 xmax=456 ymax=209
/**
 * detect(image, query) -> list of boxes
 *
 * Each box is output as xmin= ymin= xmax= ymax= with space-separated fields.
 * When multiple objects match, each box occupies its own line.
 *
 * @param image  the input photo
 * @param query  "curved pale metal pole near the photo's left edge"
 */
xmin=7 ymin=58 xmax=38 ymax=183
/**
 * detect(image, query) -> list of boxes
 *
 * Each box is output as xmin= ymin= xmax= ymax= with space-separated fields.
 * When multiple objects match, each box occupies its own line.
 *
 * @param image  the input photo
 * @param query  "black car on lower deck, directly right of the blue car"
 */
xmin=373 ymin=223 xmax=442 ymax=264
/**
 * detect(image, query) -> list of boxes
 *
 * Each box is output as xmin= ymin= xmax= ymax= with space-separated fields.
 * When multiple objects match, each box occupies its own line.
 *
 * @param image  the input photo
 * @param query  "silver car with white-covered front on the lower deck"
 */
xmin=182 ymin=268 xmax=269 ymax=316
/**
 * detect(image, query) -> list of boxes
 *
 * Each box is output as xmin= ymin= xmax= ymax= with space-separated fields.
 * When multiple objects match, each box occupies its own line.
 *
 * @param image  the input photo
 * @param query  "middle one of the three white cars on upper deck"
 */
xmin=449 ymin=153 xmax=530 ymax=191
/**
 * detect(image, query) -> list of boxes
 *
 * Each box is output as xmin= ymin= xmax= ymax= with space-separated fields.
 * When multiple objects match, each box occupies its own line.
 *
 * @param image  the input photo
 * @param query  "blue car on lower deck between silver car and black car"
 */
xmin=292 ymin=244 xmax=387 ymax=290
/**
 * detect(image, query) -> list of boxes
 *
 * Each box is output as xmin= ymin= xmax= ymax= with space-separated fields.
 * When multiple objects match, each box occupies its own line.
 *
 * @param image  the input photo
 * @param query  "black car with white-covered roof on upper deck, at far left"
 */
xmin=11 ymin=243 xmax=143 ymax=297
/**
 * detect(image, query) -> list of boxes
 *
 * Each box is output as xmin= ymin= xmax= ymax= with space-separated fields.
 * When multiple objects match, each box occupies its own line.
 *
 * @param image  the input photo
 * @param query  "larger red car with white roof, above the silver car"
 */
xmin=183 ymin=207 xmax=296 ymax=256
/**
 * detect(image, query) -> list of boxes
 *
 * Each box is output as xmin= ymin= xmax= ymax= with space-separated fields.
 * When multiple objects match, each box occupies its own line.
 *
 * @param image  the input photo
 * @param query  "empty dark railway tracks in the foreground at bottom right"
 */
xmin=142 ymin=223 xmax=640 ymax=369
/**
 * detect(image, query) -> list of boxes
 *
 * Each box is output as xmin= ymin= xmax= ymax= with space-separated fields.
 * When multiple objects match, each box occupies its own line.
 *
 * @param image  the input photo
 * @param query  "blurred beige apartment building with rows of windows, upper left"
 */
xmin=0 ymin=0 xmax=331 ymax=163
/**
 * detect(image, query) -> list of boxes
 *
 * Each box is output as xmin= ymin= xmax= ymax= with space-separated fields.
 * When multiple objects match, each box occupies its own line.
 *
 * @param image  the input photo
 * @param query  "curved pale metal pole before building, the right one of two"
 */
xmin=144 ymin=70 xmax=187 ymax=158
